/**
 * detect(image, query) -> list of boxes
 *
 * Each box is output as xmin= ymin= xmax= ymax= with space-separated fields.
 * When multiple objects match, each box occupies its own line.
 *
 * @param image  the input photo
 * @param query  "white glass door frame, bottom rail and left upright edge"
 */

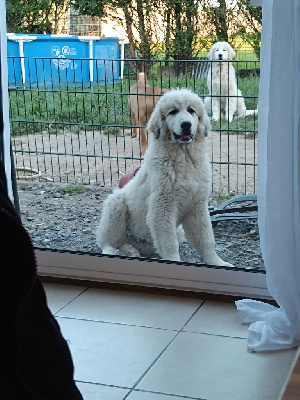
xmin=1 ymin=2 xmax=268 ymax=297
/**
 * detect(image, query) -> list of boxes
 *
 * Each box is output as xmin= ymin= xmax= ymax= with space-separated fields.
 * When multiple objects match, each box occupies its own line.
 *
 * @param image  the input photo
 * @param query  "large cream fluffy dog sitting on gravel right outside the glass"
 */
xmin=96 ymin=89 xmax=232 ymax=266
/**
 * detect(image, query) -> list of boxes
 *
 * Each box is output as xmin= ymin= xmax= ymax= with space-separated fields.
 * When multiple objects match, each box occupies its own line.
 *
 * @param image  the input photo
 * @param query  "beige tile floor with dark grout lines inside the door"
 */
xmin=44 ymin=283 xmax=296 ymax=400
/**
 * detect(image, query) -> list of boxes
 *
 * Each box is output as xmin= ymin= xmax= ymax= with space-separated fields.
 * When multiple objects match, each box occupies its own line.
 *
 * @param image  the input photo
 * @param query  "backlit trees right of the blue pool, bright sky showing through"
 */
xmin=72 ymin=0 xmax=261 ymax=68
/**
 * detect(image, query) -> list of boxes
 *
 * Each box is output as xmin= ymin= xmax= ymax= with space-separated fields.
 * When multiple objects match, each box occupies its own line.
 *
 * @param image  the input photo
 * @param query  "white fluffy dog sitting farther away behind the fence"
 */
xmin=204 ymin=42 xmax=257 ymax=122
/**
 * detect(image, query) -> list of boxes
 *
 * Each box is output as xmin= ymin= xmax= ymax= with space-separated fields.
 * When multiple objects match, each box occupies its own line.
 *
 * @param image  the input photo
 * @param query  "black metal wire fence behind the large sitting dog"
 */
xmin=9 ymin=58 xmax=259 ymax=196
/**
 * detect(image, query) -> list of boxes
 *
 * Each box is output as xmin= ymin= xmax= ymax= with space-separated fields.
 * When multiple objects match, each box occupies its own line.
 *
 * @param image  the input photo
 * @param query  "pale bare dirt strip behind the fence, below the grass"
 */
xmin=13 ymin=130 xmax=257 ymax=197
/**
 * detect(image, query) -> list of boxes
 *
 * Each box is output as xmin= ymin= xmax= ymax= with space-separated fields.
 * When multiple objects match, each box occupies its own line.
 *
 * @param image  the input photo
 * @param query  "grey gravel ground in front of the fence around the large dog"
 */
xmin=18 ymin=181 xmax=264 ymax=270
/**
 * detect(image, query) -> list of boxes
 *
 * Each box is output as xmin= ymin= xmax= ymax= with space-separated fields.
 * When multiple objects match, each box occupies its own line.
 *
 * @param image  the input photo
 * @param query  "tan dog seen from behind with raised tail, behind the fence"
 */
xmin=128 ymin=72 xmax=166 ymax=154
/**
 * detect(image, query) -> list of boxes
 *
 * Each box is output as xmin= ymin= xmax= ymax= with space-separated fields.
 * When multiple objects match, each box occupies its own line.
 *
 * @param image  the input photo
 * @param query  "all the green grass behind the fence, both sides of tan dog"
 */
xmin=10 ymin=69 xmax=259 ymax=135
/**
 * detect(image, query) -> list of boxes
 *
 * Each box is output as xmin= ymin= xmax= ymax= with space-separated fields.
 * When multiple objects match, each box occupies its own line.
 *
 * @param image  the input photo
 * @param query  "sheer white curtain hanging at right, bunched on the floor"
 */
xmin=236 ymin=0 xmax=300 ymax=351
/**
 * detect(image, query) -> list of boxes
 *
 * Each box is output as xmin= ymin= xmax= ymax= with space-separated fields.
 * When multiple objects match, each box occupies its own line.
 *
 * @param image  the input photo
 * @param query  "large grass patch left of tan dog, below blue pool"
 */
xmin=10 ymin=84 xmax=130 ymax=135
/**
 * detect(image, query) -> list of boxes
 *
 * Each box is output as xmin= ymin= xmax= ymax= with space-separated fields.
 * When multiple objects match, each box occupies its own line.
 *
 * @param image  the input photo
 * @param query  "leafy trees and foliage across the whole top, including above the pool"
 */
xmin=7 ymin=0 xmax=262 ymax=62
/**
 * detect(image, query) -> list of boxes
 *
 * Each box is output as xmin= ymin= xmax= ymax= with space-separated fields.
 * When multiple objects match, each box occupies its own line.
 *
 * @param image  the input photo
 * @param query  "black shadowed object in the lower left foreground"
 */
xmin=0 ymin=162 xmax=83 ymax=400
